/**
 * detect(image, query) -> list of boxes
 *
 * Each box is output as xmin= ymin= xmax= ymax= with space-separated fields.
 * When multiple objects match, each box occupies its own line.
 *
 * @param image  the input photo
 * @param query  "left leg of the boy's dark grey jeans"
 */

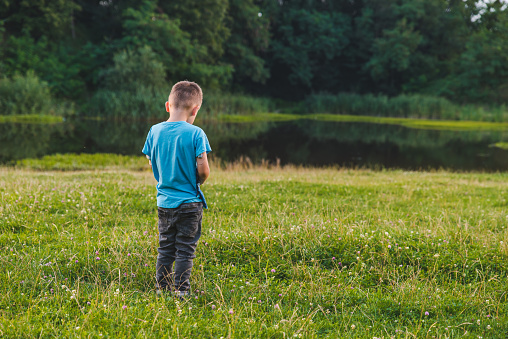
xmin=155 ymin=207 xmax=176 ymax=290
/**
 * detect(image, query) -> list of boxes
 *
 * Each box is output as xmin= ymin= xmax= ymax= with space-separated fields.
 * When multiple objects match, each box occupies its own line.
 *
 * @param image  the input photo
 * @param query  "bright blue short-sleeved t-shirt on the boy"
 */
xmin=142 ymin=121 xmax=212 ymax=208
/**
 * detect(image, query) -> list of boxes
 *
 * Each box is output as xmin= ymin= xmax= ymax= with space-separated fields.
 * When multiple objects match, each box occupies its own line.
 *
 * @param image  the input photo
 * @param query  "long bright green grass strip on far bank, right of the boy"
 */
xmin=219 ymin=113 xmax=508 ymax=131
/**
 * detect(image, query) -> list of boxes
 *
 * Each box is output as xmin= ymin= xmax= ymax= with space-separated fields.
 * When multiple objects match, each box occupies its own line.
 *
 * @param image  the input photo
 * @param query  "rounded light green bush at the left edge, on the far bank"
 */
xmin=0 ymin=71 xmax=72 ymax=115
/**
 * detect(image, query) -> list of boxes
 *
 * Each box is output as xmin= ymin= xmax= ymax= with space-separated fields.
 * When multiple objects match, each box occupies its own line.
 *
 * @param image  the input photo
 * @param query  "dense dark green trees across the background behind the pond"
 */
xmin=0 ymin=0 xmax=508 ymax=109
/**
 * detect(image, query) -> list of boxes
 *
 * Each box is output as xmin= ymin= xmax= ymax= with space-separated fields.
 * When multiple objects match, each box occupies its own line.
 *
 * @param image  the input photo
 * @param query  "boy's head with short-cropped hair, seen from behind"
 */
xmin=166 ymin=81 xmax=203 ymax=122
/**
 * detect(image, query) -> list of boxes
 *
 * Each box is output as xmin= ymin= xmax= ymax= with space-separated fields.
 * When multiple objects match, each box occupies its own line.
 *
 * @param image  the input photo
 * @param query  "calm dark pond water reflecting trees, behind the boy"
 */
xmin=0 ymin=120 xmax=508 ymax=171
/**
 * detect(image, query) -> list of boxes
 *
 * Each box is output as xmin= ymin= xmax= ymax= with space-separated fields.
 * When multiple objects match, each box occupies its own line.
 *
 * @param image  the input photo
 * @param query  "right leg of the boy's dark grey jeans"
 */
xmin=174 ymin=202 xmax=203 ymax=291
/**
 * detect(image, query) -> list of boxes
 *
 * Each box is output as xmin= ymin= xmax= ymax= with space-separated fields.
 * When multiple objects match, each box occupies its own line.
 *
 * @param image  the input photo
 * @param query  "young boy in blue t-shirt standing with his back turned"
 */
xmin=143 ymin=81 xmax=211 ymax=297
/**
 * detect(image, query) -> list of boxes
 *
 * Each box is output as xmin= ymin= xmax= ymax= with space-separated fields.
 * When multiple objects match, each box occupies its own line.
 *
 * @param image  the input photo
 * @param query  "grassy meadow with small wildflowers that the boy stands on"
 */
xmin=0 ymin=157 xmax=508 ymax=338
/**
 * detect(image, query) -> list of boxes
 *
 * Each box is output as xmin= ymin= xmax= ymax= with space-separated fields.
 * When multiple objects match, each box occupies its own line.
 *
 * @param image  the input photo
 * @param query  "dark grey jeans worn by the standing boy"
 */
xmin=156 ymin=202 xmax=203 ymax=291
